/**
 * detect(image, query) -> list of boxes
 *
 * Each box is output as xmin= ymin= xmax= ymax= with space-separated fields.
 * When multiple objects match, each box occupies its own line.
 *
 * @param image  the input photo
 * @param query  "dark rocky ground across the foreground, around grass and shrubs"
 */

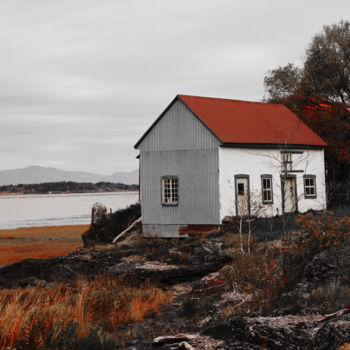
xmin=0 ymin=232 xmax=350 ymax=350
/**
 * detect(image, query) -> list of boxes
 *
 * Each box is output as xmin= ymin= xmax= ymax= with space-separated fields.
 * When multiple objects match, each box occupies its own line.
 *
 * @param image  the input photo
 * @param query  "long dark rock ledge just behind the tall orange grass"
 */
xmin=0 ymin=249 xmax=227 ymax=288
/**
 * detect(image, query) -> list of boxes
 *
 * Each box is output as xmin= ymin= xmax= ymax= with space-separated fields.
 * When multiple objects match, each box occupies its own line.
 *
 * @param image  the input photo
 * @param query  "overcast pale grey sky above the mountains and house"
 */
xmin=0 ymin=0 xmax=350 ymax=175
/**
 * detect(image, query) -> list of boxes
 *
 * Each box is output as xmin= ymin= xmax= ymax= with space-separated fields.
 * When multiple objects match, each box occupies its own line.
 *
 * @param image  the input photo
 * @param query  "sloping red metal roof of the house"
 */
xmin=178 ymin=95 xmax=327 ymax=147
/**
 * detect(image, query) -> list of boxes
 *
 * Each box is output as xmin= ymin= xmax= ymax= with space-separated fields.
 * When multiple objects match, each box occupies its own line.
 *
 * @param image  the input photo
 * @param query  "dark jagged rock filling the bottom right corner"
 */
xmin=204 ymin=309 xmax=350 ymax=350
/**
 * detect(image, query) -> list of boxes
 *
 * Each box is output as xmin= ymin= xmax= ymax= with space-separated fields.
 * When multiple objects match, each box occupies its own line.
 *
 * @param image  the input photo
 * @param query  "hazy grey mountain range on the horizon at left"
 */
xmin=0 ymin=166 xmax=139 ymax=186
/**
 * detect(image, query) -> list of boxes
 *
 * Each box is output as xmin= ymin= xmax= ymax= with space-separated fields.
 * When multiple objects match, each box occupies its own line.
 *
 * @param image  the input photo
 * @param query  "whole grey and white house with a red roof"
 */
xmin=135 ymin=95 xmax=327 ymax=237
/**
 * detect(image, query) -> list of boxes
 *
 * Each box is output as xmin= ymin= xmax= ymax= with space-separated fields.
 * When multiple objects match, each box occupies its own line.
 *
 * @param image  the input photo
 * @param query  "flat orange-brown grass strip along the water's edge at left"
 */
xmin=0 ymin=225 xmax=88 ymax=266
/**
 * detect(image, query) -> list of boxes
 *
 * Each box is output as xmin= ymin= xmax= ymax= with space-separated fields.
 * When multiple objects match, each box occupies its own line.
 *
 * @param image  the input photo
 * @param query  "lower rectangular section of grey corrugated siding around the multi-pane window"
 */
xmin=141 ymin=149 xmax=220 ymax=225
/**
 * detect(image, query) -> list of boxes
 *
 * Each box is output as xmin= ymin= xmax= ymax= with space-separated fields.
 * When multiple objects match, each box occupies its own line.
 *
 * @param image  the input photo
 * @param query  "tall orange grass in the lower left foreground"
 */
xmin=0 ymin=277 xmax=171 ymax=349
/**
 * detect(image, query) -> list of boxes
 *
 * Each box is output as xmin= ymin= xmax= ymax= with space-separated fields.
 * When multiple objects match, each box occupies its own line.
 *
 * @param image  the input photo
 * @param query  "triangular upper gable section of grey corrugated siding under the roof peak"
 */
xmin=139 ymin=101 xmax=219 ymax=152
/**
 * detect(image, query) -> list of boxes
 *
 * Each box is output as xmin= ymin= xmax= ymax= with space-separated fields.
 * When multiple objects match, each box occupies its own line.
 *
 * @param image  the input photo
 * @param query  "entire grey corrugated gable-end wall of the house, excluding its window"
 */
xmin=139 ymin=101 xmax=220 ymax=225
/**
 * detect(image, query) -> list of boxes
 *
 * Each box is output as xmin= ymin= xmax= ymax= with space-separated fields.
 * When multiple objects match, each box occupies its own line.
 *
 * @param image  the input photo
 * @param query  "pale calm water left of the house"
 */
xmin=0 ymin=192 xmax=138 ymax=229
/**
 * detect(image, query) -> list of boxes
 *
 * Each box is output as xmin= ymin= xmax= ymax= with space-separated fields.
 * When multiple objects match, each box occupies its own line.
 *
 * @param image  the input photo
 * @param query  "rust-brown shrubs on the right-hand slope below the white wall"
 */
xmin=220 ymin=212 xmax=350 ymax=314
